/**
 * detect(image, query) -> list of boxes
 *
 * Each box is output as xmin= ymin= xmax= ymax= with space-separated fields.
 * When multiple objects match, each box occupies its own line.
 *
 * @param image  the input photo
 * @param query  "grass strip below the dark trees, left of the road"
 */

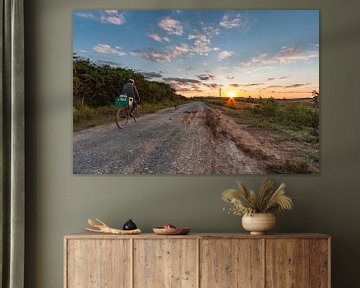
xmin=73 ymin=100 xmax=183 ymax=131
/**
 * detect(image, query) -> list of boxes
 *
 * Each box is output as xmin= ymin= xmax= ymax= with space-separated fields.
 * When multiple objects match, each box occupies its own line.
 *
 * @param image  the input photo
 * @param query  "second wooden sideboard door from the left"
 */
xmin=134 ymin=239 xmax=198 ymax=288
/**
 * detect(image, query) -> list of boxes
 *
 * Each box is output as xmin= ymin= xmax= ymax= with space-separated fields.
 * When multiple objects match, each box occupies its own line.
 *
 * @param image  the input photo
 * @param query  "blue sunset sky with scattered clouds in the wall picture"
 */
xmin=73 ymin=10 xmax=319 ymax=98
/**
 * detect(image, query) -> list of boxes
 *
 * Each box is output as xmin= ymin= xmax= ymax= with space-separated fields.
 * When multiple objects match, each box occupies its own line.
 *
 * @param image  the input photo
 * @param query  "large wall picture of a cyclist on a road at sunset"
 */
xmin=73 ymin=10 xmax=320 ymax=175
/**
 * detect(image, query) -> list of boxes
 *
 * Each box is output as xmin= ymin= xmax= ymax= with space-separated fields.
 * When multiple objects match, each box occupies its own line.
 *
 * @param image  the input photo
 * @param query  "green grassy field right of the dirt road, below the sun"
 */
xmin=202 ymin=98 xmax=320 ymax=174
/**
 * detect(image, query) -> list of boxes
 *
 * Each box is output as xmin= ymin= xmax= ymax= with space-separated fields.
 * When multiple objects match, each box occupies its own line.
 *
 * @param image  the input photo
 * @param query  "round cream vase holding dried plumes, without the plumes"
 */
xmin=242 ymin=213 xmax=276 ymax=235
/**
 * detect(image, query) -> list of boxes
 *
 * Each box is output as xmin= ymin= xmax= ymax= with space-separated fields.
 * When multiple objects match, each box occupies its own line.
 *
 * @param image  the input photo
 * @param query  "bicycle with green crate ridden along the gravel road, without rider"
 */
xmin=115 ymin=95 xmax=143 ymax=129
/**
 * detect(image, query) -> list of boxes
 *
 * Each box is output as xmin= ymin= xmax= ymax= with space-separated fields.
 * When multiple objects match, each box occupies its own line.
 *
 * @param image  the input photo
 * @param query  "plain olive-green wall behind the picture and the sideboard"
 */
xmin=24 ymin=0 xmax=360 ymax=288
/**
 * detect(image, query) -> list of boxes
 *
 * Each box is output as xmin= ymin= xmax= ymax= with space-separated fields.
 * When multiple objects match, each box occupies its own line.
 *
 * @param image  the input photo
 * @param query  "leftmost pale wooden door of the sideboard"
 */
xmin=65 ymin=239 xmax=132 ymax=288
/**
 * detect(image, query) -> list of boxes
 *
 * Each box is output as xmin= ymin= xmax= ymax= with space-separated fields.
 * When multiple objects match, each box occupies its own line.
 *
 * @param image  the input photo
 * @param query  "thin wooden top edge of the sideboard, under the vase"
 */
xmin=64 ymin=232 xmax=330 ymax=239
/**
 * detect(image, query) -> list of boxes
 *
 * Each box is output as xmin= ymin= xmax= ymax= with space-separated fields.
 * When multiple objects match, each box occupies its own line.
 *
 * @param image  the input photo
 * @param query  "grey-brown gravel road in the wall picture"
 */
xmin=73 ymin=102 xmax=264 ymax=174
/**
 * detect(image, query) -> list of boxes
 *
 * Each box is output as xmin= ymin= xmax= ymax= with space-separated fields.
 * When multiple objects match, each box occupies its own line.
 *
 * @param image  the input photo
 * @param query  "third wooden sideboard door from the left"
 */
xmin=200 ymin=239 xmax=264 ymax=288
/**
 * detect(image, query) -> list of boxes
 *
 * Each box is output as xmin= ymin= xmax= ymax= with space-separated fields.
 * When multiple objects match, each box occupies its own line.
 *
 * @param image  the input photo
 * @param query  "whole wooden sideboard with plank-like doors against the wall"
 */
xmin=64 ymin=233 xmax=331 ymax=288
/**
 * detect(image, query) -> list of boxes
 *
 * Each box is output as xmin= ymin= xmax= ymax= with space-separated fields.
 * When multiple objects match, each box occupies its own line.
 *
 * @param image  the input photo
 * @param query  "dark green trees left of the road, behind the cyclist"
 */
xmin=73 ymin=54 xmax=185 ymax=108
